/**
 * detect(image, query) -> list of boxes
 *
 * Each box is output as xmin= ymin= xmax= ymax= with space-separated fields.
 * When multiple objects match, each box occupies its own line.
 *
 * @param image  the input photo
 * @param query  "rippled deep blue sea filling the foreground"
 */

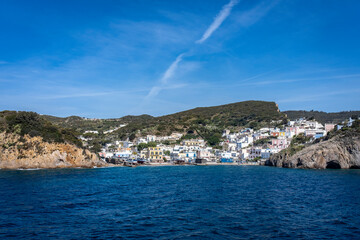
xmin=0 ymin=166 xmax=360 ymax=239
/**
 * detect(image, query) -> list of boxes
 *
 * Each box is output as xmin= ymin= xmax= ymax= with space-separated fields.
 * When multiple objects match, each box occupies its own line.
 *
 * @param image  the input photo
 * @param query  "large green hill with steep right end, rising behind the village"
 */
xmin=111 ymin=101 xmax=285 ymax=142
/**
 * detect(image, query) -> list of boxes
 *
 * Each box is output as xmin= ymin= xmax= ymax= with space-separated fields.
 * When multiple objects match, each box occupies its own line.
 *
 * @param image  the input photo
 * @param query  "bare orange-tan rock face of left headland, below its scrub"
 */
xmin=0 ymin=132 xmax=107 ymax=169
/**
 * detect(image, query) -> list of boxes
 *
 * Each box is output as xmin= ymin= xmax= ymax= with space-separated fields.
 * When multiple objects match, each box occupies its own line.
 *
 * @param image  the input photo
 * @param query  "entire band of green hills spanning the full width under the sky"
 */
xmin=0 ymin=101 xmax=360 ymax=151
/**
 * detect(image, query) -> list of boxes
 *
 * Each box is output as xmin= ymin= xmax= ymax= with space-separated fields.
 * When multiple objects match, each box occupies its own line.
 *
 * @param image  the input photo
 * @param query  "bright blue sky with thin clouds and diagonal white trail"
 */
xmin=0 ymin=0 xmax=360 ymax=118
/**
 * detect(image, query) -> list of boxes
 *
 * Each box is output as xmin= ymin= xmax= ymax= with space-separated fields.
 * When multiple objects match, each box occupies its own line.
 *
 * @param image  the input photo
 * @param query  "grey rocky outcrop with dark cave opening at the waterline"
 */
xmin=265 ymin=132 xmax=360 ymax=169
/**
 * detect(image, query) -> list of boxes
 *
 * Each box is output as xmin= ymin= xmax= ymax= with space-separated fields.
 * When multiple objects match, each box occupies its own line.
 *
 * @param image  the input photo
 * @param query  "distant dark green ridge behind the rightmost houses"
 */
xmin=284 ymin=111 xmax=360 ymax=124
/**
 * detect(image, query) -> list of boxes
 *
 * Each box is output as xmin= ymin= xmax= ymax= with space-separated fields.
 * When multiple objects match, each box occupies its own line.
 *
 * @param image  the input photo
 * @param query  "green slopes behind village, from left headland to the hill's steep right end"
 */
xmin=41 ymin=101 xmax=287 ymax=146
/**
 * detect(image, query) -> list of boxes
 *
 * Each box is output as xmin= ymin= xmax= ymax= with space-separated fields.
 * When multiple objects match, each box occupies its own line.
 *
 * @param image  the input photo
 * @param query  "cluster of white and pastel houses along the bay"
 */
xmin=95 ymin=118 xmax=353 ymax=165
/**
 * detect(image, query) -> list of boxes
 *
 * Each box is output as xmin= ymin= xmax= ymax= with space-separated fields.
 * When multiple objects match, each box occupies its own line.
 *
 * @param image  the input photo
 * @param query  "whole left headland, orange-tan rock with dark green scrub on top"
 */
xmin=0 ymin=111 xmax=107 ymax=169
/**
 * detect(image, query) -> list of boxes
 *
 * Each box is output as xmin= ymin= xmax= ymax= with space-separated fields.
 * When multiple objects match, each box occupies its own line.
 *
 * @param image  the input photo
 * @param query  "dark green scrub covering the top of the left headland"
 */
xmin=0 ymin=111 xmax=82 ymax=147
